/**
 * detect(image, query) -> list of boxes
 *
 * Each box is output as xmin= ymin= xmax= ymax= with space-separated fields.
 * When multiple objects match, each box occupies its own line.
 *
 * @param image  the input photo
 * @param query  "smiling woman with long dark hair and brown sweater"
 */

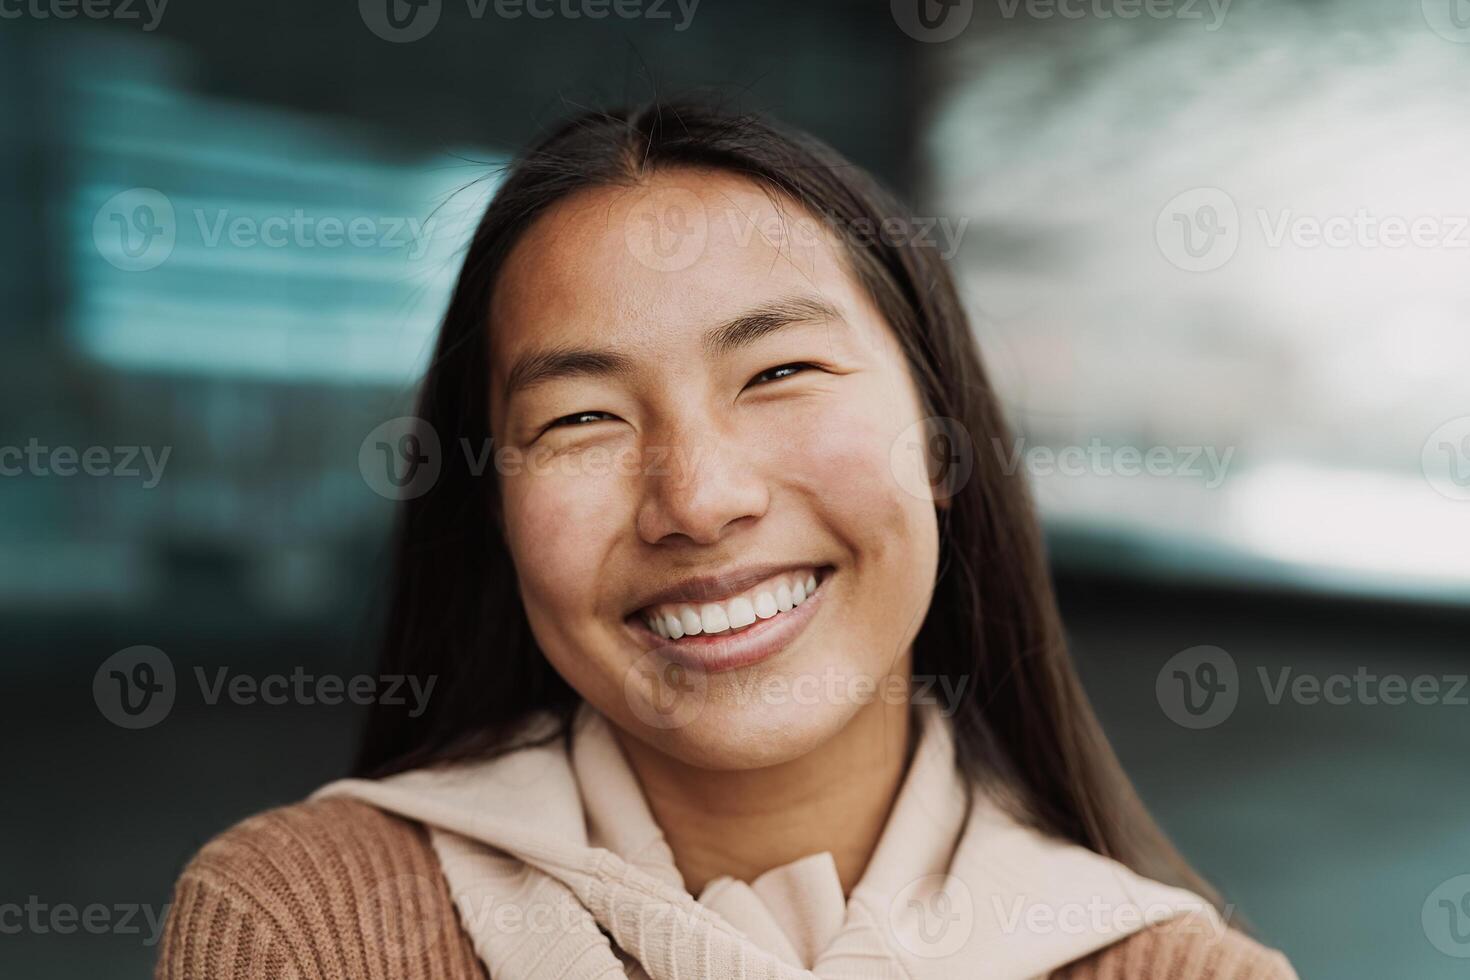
xmin=159 ymin=104 xmax=1294 ymax=980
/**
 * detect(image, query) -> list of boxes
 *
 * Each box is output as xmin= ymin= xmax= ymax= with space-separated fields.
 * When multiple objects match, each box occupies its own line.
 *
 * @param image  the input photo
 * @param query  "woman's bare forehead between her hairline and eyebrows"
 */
xmin=491 ymin=169 xmax=864 ymax=371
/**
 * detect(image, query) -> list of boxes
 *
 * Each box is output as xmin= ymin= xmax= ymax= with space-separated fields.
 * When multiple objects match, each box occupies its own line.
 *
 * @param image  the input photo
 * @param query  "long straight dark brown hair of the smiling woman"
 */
xmin=354 ymin=103 xmax=1219 ymax=905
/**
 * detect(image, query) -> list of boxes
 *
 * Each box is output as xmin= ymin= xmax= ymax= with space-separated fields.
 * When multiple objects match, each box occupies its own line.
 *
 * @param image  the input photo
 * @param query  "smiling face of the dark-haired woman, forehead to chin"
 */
xmin=491 ymin=170 xmax=938 ymax=768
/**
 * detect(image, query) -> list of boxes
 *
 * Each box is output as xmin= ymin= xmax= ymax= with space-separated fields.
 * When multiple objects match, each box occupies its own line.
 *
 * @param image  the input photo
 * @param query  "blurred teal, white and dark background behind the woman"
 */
xmin=0 ymin=0 xmax=1470 ymax=979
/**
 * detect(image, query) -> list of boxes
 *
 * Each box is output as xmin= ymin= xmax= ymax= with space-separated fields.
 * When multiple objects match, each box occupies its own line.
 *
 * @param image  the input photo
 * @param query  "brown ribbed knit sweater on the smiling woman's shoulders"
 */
xmin=154 ymin=799 xmax=1297 ymax=980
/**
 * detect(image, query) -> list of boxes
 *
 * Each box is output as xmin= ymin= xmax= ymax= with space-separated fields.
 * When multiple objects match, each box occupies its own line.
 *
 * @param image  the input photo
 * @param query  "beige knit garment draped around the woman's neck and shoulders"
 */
xmin=315 ymin=705 xmax=1226 ymax=980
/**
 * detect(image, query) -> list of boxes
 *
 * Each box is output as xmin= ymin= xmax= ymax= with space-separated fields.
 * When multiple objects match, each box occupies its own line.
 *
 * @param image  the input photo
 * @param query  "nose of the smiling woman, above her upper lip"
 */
xmin=638 ymin=419 xmax=770 ymax=545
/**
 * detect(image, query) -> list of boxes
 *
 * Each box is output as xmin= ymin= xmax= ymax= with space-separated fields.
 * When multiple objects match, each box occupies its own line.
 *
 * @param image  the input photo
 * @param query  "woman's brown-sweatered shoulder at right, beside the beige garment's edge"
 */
xmin=1051 ymin=917 xmax=1297 ymax=980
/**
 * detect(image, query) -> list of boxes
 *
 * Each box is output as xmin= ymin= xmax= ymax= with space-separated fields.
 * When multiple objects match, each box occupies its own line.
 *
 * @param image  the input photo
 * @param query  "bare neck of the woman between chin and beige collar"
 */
xmin=619 ymin=698 xmax=911 ymax=896
